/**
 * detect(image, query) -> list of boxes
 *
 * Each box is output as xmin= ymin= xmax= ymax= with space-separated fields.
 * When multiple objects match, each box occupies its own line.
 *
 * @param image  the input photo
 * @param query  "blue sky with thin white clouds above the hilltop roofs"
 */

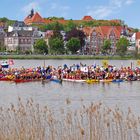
xmin=0 ymin=0 xmax=140 ymax=28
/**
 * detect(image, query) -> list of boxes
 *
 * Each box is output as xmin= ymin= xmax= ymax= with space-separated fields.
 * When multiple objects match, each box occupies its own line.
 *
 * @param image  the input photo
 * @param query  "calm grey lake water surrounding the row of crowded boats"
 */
xmin=0 ymin=60 xmax=140 ymax=114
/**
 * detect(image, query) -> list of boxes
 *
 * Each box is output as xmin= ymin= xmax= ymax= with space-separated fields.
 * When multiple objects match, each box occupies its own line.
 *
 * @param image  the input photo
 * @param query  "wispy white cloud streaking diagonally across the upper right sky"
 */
xmin=87 ymin=0 xmax=134 ymax=18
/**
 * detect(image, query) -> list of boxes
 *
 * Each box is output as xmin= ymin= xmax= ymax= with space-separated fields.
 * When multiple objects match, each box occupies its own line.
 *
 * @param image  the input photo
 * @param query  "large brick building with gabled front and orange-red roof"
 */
xmin=83 ymin=26 xmax=121 ymax=54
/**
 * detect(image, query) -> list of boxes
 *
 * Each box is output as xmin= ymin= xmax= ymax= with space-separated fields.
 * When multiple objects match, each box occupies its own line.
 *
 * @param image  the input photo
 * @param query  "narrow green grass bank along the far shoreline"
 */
xmin=0 ymin=55 xmax=140 ymax=60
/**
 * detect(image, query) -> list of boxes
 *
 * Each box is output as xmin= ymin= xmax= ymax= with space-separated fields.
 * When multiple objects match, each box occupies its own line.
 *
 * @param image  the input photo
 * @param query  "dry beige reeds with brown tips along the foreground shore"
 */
xmin=0 ymin=98 xmax=140 ymax=140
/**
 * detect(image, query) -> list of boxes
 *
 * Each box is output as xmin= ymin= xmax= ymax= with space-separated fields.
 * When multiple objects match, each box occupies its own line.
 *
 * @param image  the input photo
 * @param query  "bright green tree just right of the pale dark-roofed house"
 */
xmin=34 ymin=39 xmax=48 ymax=54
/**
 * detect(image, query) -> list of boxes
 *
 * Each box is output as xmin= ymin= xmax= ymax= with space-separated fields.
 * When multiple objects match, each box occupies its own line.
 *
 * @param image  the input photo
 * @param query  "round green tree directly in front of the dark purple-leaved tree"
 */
xmin=66 ymin=37 xmax=81 ymax=54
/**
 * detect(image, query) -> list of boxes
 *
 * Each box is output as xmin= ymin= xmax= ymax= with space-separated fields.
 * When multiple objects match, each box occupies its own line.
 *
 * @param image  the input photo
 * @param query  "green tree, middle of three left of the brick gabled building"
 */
xmin=49 ymin=37 xmax=65 ymax=54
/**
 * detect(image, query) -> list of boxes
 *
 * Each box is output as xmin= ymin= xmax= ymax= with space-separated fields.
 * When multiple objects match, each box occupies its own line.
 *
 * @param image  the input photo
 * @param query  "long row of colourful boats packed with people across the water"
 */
xmin=0 ymin=64 xmax=140 ymax=84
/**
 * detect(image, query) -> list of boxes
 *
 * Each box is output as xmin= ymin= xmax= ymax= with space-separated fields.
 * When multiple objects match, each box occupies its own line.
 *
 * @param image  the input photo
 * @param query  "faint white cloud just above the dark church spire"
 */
xmin=22 ymin=2 xmax=41 ymax=14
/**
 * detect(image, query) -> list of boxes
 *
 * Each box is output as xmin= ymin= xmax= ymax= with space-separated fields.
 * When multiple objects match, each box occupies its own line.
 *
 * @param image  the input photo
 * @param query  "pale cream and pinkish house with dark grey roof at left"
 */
xmin=4 ymin=30 xmax=43 ymax=52
